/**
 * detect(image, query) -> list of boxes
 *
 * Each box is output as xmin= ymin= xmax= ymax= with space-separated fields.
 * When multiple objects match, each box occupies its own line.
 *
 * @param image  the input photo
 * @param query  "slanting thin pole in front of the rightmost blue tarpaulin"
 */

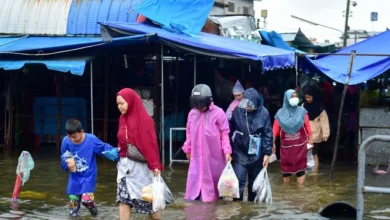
xmin=329 ymin=50 xmax=356 ymax=180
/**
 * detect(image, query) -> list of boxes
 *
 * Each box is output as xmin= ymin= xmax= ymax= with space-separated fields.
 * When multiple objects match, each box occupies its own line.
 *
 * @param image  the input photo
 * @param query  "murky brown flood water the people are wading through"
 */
xmin=0 ymin=153 xmax=390 ymax=220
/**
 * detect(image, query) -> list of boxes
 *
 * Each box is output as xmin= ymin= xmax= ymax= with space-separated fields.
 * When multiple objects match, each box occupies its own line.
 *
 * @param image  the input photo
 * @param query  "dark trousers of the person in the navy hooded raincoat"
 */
xmin=233 ymin=163 xmax=263 ymax=202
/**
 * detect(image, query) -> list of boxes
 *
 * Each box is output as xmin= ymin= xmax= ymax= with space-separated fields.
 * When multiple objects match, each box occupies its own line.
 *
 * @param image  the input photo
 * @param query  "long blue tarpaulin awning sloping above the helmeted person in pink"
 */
xmin=103 ymin=22 xmax=295 ymax=72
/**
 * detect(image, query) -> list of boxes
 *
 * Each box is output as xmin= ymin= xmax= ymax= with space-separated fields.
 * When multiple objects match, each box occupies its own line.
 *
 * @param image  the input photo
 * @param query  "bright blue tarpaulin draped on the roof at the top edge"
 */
xmin=134 ymin=0 xmax=214 ymax=36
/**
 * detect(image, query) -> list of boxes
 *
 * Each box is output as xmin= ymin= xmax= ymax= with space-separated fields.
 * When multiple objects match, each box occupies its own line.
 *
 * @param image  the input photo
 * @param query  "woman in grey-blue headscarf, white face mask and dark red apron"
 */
xmin=272 ymin=89 xmax=312 ymax=184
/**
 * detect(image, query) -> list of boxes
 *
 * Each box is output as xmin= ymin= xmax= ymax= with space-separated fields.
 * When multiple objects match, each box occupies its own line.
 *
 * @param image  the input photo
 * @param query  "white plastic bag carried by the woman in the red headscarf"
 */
xmin=152 ymin=175 xmax=173 ymax=212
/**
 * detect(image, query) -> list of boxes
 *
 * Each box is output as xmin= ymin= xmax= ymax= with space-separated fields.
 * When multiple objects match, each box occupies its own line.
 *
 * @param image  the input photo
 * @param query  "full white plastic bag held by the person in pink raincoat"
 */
xmin=218 ymin=162 xmax=240 ymax=199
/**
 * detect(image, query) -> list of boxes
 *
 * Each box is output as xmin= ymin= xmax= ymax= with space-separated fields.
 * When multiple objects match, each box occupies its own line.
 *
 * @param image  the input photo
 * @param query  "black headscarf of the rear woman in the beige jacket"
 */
xmin=303 ymin=86 xmax=324 ymax=121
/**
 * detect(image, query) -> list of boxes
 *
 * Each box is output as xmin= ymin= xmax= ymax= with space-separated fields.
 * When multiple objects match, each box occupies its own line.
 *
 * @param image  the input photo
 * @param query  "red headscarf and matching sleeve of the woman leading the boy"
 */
xmin=117 ymin=88 xmax=163 ymax=170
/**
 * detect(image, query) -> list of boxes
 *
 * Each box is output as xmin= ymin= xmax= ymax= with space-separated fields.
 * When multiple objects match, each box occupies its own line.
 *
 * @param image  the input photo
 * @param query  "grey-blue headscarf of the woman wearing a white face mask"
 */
xmin=275 ymin=89 xmax=307 ymax=134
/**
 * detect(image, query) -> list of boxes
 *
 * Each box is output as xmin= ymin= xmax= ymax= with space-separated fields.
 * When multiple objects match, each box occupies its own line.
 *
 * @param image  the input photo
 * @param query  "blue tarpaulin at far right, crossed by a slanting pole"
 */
xmin=300 ymin=31 xmax=390 ymax=85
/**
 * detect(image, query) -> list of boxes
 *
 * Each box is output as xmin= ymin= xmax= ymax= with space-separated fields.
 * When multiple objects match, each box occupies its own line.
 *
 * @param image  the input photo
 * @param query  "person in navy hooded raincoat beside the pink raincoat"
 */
xmin=230 ymin=88 xmax=272 ymax=202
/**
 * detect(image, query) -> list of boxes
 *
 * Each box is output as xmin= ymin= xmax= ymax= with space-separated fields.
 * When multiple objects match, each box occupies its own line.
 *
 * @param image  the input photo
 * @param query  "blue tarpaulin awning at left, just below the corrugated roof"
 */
xmin=0 ymin=34 xmax=155 ymax=76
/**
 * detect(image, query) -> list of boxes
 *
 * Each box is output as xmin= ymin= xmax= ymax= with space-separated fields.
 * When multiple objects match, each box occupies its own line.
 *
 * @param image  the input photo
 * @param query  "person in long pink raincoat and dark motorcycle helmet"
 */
xmin=183 ymin=84 xmax=232 ymax=202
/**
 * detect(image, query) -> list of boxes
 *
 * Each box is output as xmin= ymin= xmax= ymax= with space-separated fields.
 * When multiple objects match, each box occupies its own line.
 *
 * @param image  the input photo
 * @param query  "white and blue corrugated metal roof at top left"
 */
xmin=0 ymin=0 xmax=142 ymax=35
